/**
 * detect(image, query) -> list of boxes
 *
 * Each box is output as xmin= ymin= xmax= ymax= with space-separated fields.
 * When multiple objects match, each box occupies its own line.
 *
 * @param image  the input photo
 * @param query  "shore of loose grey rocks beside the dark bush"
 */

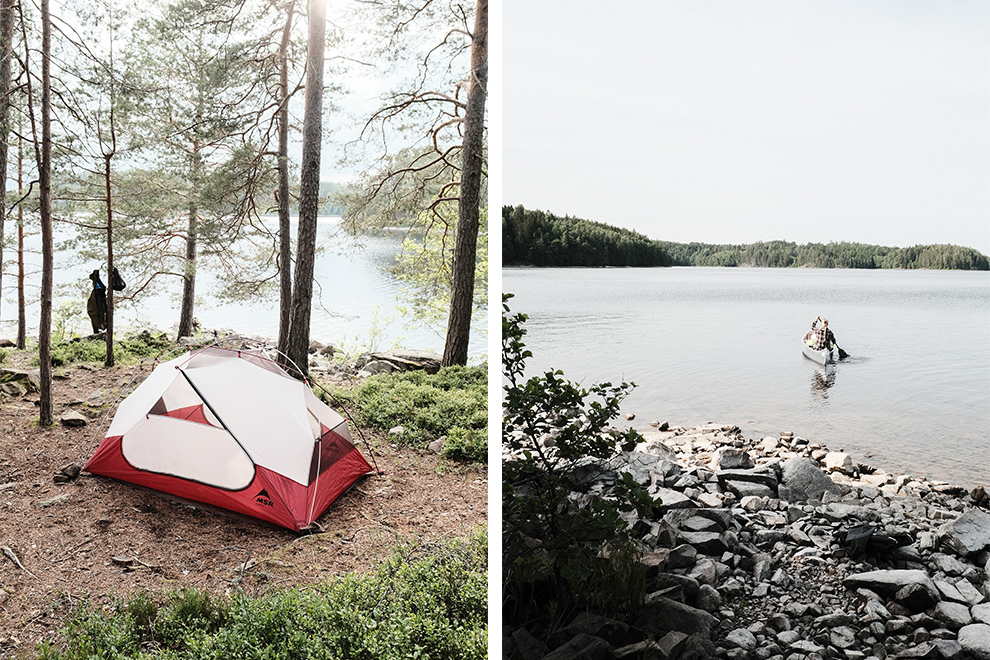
xmin=502 ymin=425 xmax=990 ymax=660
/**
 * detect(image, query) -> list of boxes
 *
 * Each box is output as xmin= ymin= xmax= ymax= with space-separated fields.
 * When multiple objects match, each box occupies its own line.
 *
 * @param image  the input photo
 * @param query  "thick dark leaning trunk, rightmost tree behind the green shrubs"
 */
xmin=441 ymin=0 xmax=488 ymax=367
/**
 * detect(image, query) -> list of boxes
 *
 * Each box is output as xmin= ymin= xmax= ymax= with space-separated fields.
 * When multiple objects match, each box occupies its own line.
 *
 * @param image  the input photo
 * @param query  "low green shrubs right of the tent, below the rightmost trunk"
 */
xmin=334 ymin=365 xmax=488 ymax=462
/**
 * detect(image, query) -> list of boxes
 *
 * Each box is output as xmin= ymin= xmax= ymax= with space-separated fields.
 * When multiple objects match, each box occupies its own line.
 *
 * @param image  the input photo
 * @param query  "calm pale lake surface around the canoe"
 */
xmin=502 ymin=268 xmax=990 ymax=486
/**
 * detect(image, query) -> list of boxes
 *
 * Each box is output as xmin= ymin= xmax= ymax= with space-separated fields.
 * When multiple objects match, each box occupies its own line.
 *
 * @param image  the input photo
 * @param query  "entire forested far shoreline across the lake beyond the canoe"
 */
xmin=502 ymin=206 xmax=990 ymax=270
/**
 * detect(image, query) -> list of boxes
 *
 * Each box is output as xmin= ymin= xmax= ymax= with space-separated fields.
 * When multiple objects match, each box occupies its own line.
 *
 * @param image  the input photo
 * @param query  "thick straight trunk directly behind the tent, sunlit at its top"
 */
xmin=285 ymin=0 xmax=327 ymax=375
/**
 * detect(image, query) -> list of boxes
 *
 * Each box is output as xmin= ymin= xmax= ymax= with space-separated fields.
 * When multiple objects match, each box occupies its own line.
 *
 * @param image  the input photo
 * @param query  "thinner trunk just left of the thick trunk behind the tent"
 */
xmin=278 ymin=2 xmax=295 ymax=353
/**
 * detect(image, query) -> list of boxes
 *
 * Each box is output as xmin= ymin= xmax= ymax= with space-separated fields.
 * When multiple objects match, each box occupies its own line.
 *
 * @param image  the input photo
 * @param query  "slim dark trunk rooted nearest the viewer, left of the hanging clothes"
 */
xmin=38 ymin=0 xmax=55 ymax=426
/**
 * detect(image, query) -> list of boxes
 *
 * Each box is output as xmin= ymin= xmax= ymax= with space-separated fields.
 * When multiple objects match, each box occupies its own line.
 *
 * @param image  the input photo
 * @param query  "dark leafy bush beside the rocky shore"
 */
xmin=502 ymin=295 xmax=659 ymax=621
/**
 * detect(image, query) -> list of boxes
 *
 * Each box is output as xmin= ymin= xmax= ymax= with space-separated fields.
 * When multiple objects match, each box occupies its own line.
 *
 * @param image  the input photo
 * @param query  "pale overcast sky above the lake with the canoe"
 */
xmin=501 ymin=0 xmax=990 ymax=254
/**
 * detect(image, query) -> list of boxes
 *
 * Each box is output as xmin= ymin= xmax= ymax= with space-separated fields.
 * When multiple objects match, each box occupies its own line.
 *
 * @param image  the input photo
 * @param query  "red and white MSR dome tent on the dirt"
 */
xmin=85 ymin=347 xmax=371 ymax=530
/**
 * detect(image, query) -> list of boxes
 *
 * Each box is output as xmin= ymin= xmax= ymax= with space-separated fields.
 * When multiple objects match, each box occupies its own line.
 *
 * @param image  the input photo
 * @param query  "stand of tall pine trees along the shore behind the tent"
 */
xmin=0 ymin=0 xmax=488 ymax=425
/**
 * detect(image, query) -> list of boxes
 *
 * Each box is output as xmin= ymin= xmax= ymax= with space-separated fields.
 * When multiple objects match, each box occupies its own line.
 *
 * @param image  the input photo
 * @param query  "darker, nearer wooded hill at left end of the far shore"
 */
xmin=502 ymin=206 xmax=670 ymax=266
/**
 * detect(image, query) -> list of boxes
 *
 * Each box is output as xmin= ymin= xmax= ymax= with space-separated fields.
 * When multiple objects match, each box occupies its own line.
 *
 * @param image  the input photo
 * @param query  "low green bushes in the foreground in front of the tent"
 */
xmin=38 ymin=530 xmax=488 ymax=660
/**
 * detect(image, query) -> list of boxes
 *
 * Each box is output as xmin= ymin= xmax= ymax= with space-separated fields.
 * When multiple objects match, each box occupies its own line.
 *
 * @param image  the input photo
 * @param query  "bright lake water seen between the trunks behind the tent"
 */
xmin=0 ymin=217 xmax=487 ymax=362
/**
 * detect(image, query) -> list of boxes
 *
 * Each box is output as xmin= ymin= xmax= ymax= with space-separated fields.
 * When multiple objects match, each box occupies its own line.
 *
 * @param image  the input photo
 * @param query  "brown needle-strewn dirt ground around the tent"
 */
xmin=0 ymin=358 xmax=488 ymax=658
